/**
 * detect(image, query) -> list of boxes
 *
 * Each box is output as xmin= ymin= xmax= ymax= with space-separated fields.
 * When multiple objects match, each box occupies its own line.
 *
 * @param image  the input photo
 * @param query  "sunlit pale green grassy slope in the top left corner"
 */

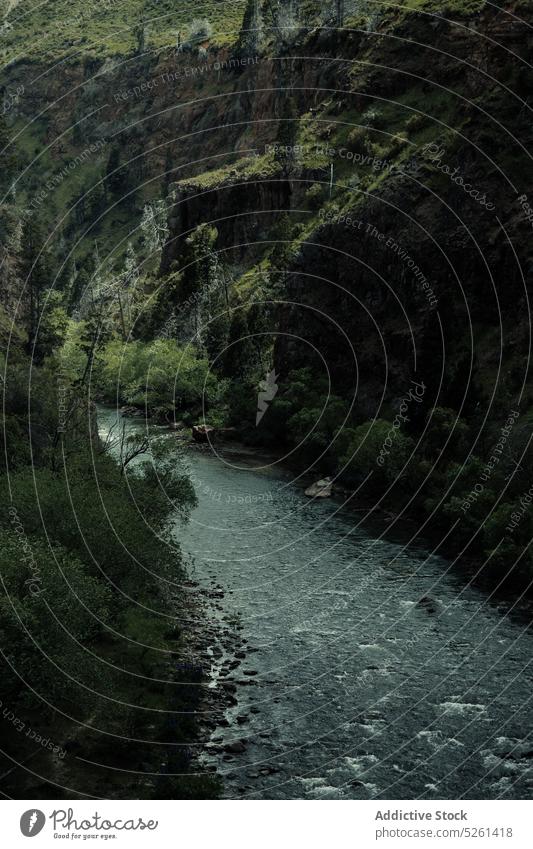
xmin=0 ymin=0 xmax=245 ymax=66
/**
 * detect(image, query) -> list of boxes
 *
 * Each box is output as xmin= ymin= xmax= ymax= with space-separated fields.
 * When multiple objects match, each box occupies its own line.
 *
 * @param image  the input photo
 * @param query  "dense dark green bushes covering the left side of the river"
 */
xmin=0 ymin=342 xmax=217 ymax=797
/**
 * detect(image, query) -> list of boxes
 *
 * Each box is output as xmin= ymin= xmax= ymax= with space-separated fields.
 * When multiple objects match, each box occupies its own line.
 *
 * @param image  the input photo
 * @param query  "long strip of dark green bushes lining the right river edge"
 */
xmin=109 ymin=407 xmax=533 ymax=595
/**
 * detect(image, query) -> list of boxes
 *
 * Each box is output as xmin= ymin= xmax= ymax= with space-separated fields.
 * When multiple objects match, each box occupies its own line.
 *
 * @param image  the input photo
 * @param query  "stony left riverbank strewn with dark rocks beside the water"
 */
xmin=97 ymin=406 xmax=256 ymax=798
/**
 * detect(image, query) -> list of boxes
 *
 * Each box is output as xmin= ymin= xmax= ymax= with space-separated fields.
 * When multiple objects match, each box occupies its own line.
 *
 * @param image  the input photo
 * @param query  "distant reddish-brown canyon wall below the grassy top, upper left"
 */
xmin=3 ymin=40 xmax=306 ymax=268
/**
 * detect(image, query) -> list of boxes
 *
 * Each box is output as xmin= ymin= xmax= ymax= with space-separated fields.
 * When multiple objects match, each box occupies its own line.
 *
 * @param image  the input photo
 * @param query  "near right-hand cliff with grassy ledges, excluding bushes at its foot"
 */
xmin=157 ymin=3 xmax=533 ymax=418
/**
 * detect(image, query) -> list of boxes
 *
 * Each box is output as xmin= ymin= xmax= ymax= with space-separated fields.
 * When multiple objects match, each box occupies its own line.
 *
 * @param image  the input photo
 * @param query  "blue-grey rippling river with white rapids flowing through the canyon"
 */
xmin=99 ymin=410 xmax=533 ymax=799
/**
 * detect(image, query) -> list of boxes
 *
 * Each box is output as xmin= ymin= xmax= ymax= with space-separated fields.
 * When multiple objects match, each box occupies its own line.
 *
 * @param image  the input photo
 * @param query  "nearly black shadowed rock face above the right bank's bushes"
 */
xmin=276 ymin=185 xmax=528 ymax=419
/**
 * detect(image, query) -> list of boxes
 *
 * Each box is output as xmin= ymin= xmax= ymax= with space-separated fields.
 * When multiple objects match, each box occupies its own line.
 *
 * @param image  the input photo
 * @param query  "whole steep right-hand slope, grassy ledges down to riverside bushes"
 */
xmin=151 ymin=4 xmax=533 ymax=576
